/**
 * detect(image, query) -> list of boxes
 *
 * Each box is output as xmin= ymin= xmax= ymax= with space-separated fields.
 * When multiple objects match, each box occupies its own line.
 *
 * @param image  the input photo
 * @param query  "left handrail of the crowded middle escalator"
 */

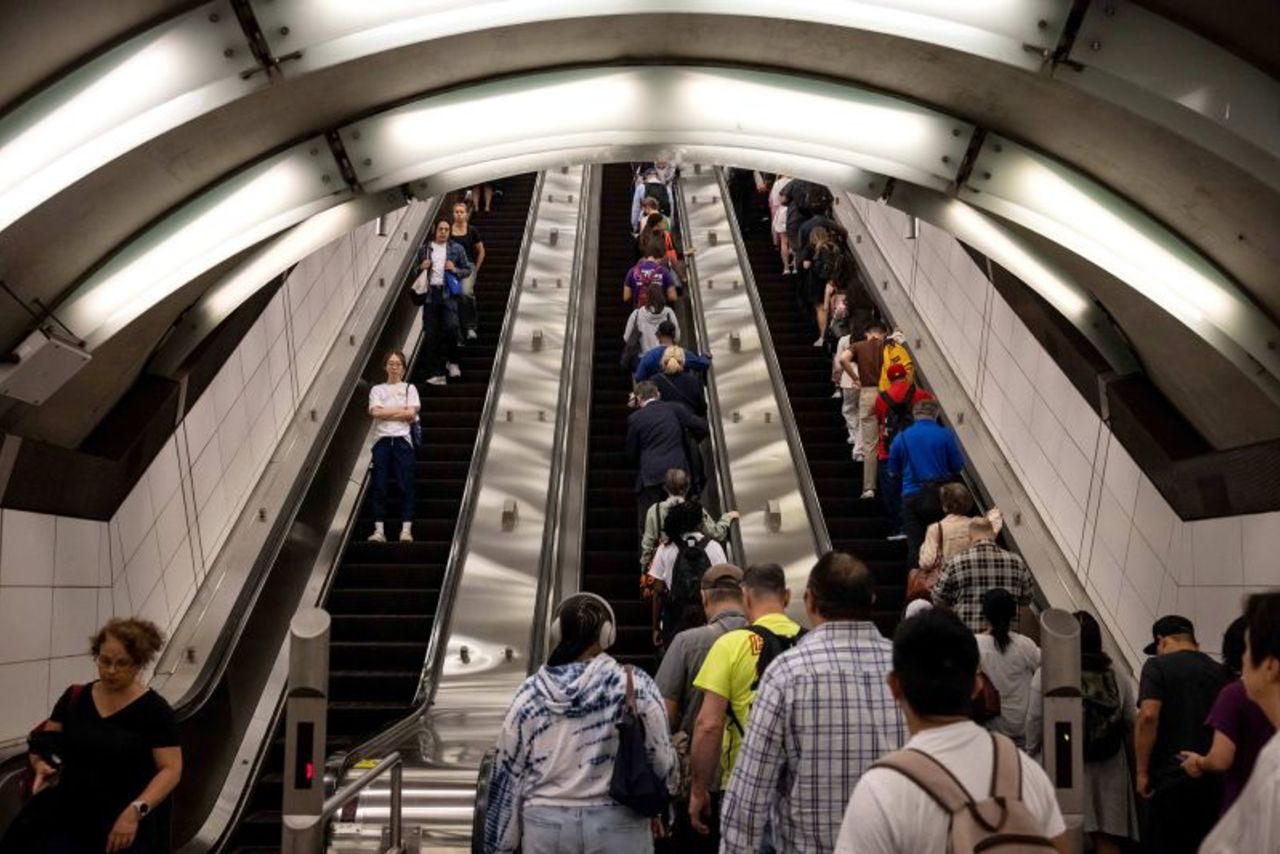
xmin=529 ymin=165 xmax=600 ymax=672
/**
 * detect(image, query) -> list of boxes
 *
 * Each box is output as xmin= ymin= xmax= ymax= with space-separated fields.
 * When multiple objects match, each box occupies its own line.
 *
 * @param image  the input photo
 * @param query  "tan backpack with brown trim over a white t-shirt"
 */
xmin=872 ymin=732 xmax=1056 ymax=854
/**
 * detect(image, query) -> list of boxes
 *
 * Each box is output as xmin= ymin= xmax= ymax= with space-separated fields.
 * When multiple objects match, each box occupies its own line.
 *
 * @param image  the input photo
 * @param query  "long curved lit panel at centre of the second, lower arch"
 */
xmin=340 ymin=67 xmax=973 ymax=189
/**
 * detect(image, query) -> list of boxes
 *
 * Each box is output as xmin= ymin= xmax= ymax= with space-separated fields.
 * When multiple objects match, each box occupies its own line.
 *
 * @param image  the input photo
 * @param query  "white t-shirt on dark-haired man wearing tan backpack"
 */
xmin=836 ymin=721 xmax=1066 ymax=854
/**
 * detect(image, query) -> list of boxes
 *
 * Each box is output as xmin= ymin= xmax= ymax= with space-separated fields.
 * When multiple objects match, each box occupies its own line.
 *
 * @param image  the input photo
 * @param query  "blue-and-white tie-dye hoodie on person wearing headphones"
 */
xmin=484 ymin=653 xmax=680 ymax=851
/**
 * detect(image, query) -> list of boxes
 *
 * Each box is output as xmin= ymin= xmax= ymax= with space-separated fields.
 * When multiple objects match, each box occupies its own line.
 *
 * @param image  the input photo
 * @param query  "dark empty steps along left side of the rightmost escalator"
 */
xmin=744 ymin=203 xmax=908 ymax=636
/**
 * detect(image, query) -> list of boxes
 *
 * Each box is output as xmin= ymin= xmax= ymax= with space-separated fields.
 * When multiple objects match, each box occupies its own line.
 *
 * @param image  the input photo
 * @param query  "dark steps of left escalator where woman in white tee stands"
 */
xmin=227 ymin=175 xmax=535 ymax=853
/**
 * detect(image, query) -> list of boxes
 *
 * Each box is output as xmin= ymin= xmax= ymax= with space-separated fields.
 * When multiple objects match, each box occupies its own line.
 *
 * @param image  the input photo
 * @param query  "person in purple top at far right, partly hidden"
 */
xmin=1180 ymin=617 xmax=1275 ymax=813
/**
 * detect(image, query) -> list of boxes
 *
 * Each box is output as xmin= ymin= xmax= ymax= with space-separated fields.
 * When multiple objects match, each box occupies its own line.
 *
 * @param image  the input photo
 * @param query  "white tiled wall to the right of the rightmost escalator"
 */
xmin=851 ymin=198 xmax=1280 ymax=668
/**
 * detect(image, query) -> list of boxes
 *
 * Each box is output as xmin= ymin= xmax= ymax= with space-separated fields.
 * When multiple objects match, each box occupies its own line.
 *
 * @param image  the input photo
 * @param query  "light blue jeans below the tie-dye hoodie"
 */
xmin=521 ymin=804 xmax=653 ymax=854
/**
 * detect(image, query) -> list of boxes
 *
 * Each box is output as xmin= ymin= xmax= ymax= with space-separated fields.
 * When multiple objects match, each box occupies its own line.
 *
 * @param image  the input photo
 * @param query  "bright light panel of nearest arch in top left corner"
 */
xmin=0 ymin=0 xmax=268 ymax=230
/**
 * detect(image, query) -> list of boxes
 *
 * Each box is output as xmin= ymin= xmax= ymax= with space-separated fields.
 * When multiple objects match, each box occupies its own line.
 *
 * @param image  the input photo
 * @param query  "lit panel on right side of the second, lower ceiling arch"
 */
xmin=960 ymin=134 xmax=1280 ymax=396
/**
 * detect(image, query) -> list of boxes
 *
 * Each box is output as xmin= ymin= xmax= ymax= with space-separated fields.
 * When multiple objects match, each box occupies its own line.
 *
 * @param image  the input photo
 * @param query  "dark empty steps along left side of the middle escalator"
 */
xmin=582 ymin=164 xmax=655 ymax=672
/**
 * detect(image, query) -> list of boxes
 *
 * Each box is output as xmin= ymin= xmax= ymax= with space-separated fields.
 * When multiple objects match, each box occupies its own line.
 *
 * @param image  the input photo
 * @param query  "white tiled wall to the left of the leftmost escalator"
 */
xmin=0 ymin=211 xmax=403 ymax=743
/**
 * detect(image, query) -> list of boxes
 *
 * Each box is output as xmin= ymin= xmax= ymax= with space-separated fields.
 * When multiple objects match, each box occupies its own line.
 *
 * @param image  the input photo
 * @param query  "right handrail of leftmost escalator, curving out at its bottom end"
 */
xmin=325 ymin=173 xmax=544 ymax=780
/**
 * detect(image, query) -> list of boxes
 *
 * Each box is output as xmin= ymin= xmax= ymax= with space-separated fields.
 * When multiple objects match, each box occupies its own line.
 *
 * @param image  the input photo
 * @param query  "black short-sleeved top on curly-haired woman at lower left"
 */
xmin=49 ymin=684 xmax=178 ymax=850
